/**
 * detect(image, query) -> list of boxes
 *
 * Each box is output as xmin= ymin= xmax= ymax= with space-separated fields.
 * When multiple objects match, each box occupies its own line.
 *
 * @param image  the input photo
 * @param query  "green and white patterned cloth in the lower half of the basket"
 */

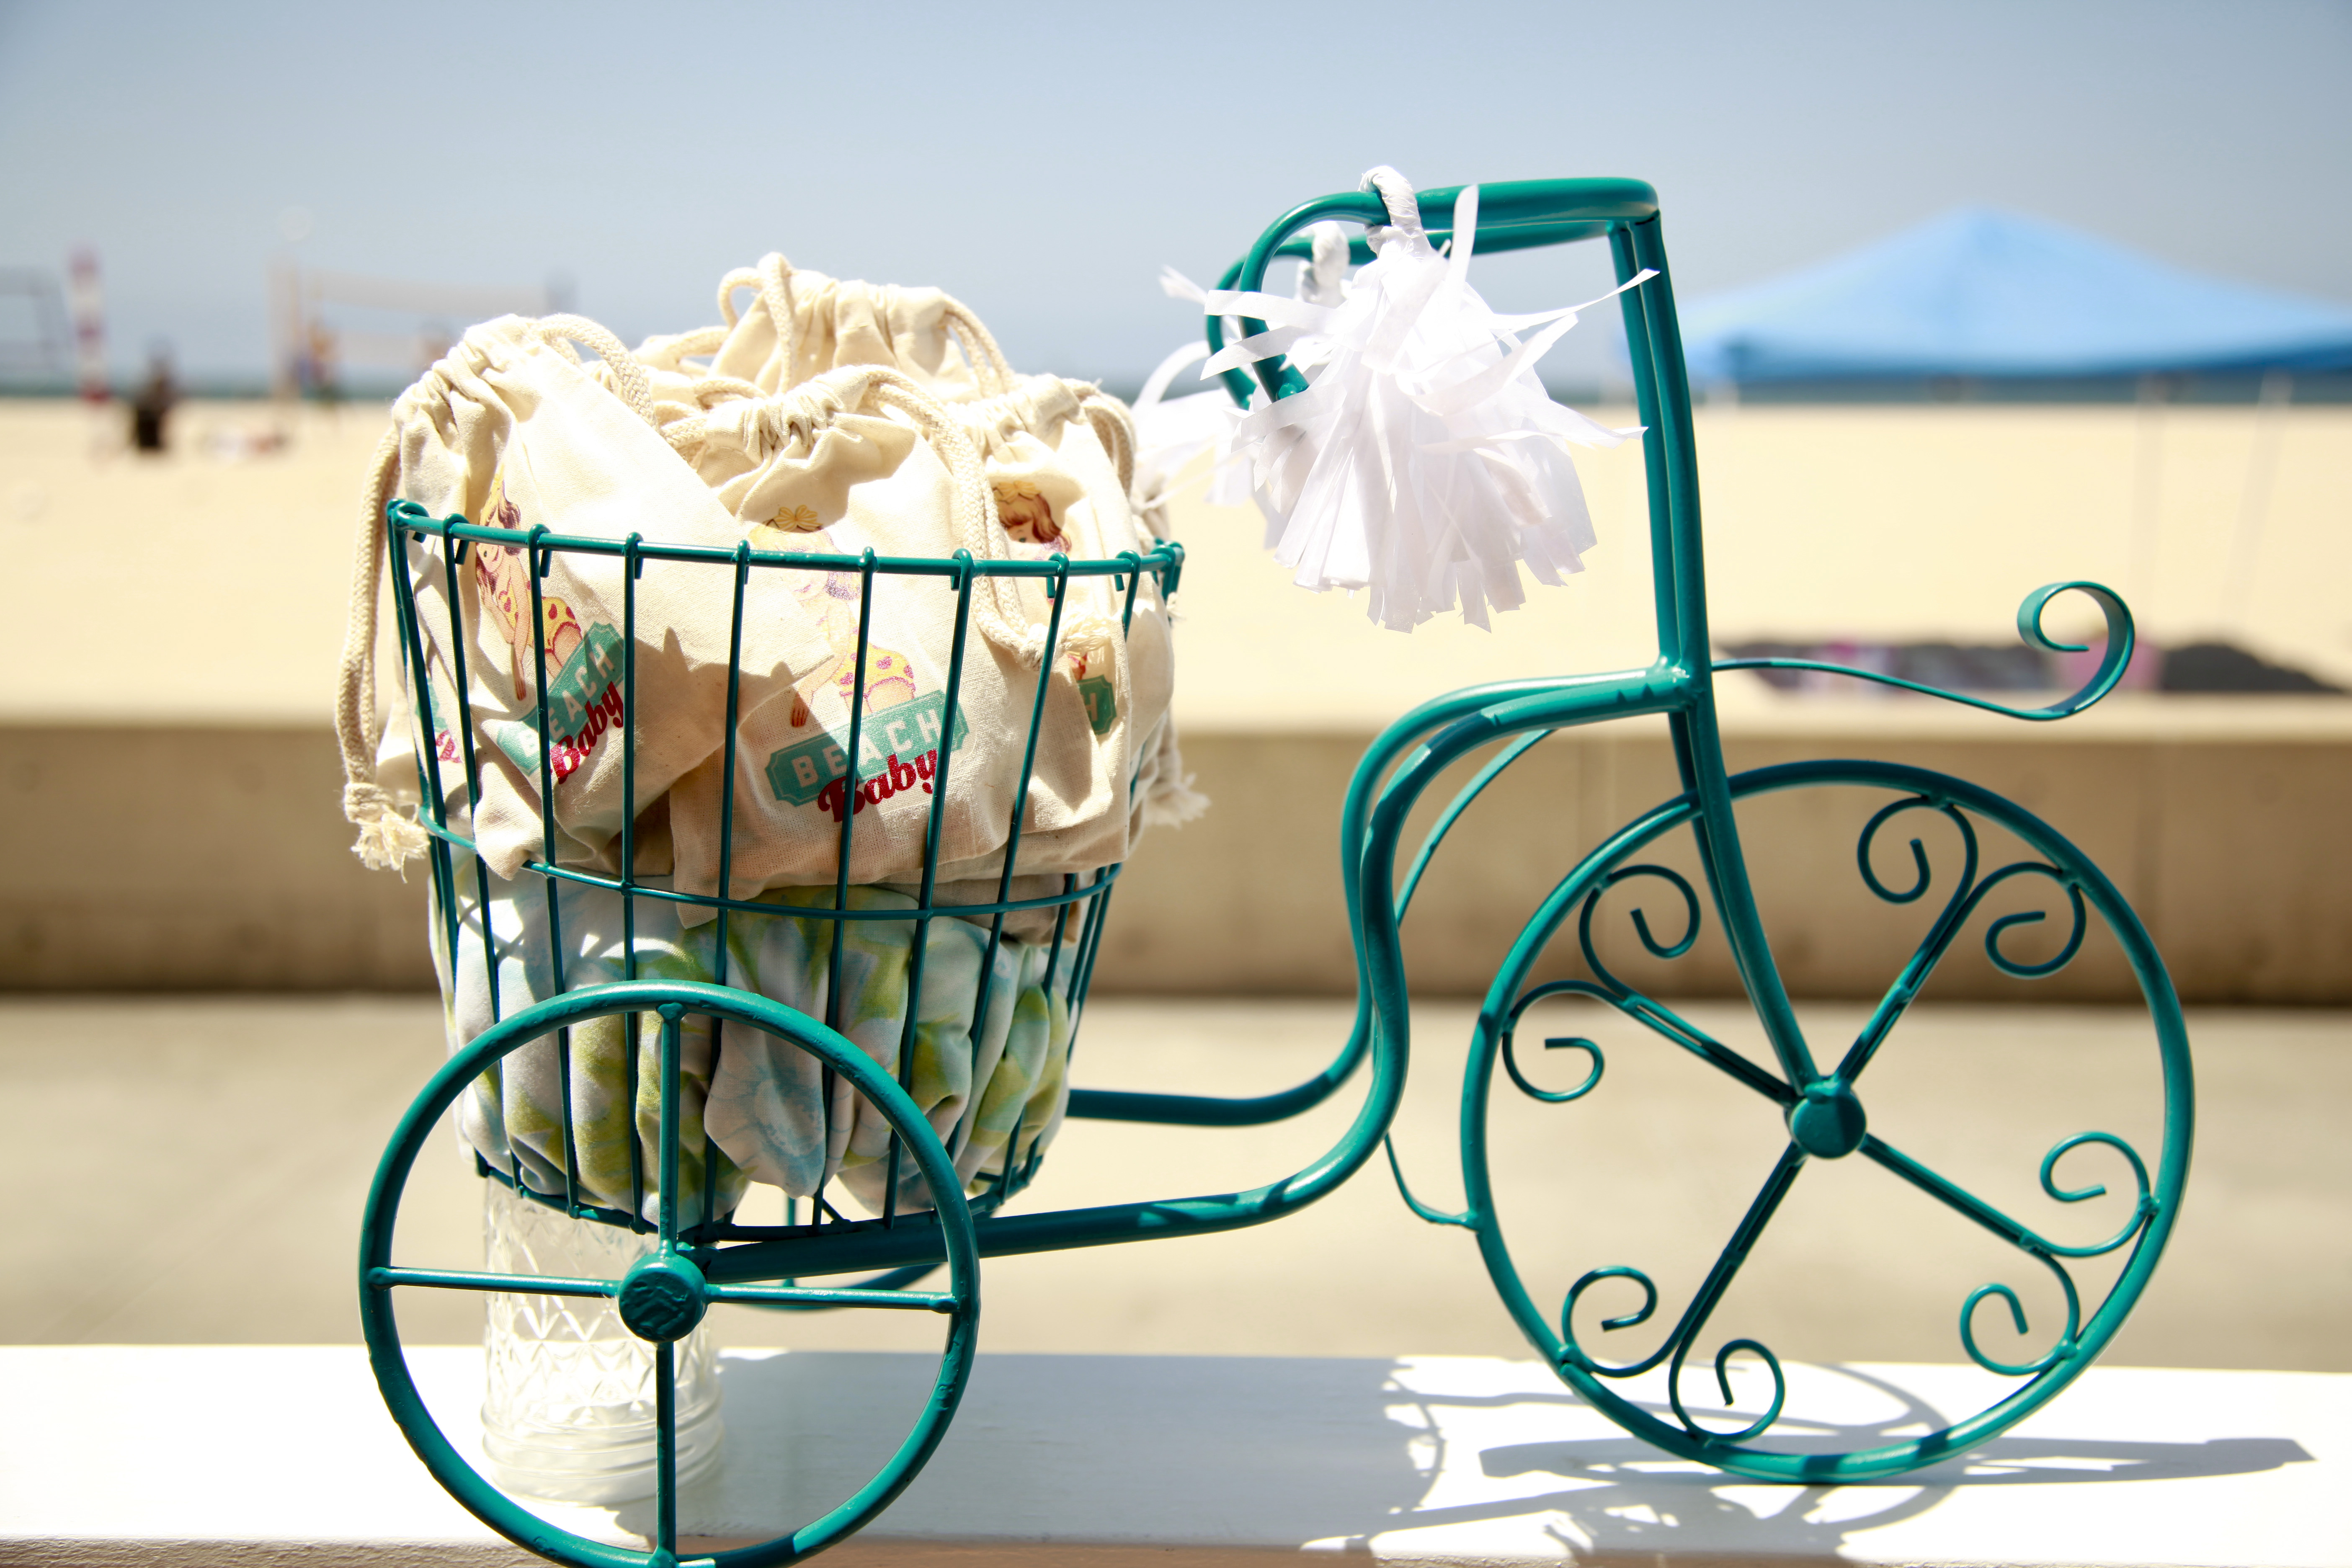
xmin=433 ymin=867 xmax=1077 ymax=1220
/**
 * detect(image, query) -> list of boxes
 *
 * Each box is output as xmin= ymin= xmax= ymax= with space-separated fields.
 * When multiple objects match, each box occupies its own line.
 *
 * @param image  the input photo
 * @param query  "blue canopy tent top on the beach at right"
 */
xmin=1681 ymin=209 xmax=2352 ymax=383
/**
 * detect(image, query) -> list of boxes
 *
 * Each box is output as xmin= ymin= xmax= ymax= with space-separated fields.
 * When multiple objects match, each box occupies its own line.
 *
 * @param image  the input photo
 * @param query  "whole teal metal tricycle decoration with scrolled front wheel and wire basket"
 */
xmin=360 ymin=179 xmax=2192 ymax=1568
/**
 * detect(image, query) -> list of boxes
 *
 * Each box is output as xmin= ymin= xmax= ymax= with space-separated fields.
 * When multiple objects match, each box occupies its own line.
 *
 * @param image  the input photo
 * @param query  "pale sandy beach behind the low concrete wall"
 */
xmin=0 ymin=402 xmax=2352 ymax=729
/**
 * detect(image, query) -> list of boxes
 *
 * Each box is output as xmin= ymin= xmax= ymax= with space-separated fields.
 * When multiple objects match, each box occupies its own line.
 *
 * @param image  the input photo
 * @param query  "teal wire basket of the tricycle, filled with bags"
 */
xmin=388 ymin=501 xmax=1183 ymax=1241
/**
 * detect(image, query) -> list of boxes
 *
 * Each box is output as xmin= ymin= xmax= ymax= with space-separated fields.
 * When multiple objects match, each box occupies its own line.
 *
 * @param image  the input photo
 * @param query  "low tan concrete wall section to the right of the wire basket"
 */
xmin=1096 ymin=726 xmax=2352 ymax=1004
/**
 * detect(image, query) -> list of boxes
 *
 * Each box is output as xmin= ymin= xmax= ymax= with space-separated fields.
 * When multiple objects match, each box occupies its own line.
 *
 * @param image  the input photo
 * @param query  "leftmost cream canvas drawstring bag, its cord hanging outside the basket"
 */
xmin=336 ymin=317 xmax=842 ymax=877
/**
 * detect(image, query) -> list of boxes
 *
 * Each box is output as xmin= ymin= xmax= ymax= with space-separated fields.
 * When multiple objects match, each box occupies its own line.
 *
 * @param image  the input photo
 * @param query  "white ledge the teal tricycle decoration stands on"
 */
xmin=0 ymin=1345 xmax=2352 ymax=1568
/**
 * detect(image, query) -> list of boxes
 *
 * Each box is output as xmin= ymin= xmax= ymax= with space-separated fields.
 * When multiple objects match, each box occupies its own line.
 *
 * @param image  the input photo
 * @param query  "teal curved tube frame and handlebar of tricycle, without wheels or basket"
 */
xmin=381 ymin=179 xmax=2131 ymax=1284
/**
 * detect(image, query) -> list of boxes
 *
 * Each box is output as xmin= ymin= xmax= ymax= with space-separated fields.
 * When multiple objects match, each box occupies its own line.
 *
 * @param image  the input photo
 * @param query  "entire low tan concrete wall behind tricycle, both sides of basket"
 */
xmin=0 ymin=703 xmax=2352 ymax=1006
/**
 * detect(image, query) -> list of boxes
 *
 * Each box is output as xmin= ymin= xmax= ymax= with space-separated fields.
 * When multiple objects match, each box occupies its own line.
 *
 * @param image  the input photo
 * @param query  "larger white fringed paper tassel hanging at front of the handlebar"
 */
xmin=1204 ymin=167 xmax=1651 ymax=630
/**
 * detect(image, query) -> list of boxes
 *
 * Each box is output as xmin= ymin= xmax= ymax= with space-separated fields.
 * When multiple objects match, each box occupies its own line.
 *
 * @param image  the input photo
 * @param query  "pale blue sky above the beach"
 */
xmin=0 ymin=0 xmax=2352 ymax=381
